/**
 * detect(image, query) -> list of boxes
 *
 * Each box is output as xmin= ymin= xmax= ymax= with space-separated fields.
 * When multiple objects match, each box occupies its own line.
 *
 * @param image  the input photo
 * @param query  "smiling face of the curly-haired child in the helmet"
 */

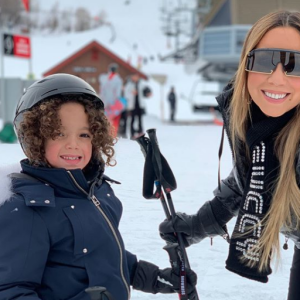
xmin=45 ymin=103 xmax=92 ymax=170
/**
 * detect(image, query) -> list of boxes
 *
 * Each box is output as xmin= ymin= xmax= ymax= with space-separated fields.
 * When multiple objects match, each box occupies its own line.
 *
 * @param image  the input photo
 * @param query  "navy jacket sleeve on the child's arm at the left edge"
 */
xmin=0 ymin=199 xmax=50 ymax=300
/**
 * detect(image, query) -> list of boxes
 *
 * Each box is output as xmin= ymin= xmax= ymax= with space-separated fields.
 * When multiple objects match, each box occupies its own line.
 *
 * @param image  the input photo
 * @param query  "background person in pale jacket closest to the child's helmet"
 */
xmin=99 ymin=63 xmax=124 ymax=134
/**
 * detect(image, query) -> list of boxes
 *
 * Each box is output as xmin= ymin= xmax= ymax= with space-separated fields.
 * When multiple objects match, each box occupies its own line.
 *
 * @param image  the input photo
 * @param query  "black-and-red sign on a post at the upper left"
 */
xmin=3 ymin=34 xmax=31 ymax=58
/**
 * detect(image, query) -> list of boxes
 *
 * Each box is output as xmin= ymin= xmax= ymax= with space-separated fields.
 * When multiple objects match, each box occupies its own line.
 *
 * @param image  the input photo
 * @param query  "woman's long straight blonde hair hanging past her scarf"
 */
xmin=230 ymin=10 xmax=300 ymax=271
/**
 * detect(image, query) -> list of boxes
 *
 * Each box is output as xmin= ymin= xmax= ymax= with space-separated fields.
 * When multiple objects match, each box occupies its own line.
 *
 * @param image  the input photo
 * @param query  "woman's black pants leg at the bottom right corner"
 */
xmin=287 ymin=247 xmax=300 ymax=300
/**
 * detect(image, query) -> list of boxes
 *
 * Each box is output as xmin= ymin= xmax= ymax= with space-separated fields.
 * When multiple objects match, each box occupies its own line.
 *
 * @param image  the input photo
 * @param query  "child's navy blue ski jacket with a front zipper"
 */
xmin=0 ymin=160 xmax=137 ymax=300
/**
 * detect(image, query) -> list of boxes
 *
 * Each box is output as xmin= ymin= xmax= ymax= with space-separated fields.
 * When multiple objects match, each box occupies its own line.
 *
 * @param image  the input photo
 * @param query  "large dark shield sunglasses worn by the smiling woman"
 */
xmin=245 ymin=48 xmax=300 ymax=77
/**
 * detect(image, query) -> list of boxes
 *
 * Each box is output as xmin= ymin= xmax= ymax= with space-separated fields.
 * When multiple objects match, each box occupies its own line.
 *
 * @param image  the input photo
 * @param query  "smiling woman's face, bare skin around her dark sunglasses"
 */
xmin=247 ymin=27 xmax=300 ymax=117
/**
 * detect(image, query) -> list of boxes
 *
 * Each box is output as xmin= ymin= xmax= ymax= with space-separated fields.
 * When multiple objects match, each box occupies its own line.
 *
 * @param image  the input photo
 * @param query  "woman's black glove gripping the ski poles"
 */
xmin=159 ymin=202 xmax=227 ymax=247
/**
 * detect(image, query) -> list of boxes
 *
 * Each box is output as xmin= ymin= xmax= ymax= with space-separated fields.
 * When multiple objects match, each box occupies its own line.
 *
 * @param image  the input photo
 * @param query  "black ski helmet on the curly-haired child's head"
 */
xmin=14 ymin=73 xmax=104 ymax=149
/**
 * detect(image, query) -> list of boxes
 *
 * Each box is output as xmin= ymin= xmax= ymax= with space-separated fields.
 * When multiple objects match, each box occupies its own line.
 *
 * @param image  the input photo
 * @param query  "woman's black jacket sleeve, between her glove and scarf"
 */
xmin=198 ymin=172 xmax=242 ymax=236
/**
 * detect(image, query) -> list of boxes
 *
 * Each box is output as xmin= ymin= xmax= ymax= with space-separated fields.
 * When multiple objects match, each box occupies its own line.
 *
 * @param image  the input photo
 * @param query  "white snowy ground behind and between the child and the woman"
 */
xmin=0 ymin=116 xmax=293 ymax=300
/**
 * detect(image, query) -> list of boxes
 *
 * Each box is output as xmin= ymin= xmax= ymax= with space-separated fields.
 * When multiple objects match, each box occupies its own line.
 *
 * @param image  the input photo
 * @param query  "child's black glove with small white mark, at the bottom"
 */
xmin=132 ymin=260 xmax=197 ymax=300
